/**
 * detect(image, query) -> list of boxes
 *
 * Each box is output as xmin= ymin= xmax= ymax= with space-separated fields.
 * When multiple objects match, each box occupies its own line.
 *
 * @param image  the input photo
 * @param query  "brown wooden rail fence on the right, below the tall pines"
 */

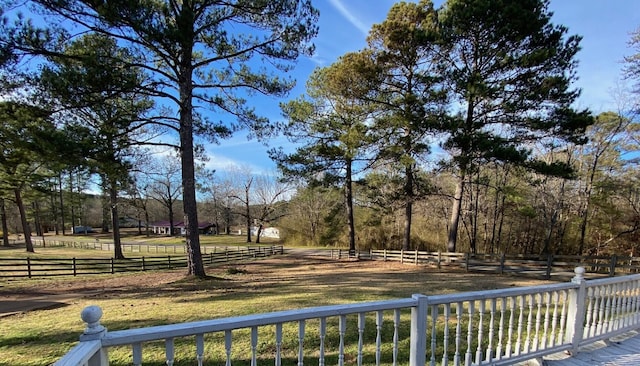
xmin=329 ymin=249 xmax=640 ymax=279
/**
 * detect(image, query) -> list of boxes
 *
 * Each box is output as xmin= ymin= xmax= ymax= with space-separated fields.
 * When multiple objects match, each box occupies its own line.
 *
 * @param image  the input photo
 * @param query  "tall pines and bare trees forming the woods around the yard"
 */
xmin=0 ymin=0 xmax=640 ymax=276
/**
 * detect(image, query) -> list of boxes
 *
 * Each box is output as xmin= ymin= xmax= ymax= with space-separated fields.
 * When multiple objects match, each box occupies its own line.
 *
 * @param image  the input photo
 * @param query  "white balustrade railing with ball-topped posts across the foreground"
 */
xmin=55 ymin=267 xmax=640 ymax=366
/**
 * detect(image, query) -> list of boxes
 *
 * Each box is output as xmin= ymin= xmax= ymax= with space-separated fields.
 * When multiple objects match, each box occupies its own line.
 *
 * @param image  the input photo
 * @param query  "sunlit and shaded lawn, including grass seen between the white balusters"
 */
xmin=0 ymin=252 xmax=542 ymax=366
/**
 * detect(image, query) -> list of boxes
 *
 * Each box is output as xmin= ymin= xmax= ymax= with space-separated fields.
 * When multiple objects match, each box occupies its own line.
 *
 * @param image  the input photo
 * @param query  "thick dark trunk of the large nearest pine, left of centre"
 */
xmin=178 ymin=13 xmax=206 ymax=278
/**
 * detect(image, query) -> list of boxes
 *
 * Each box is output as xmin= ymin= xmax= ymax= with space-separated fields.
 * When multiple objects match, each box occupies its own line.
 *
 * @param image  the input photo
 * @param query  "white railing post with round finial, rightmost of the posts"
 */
xmin=565 ymin=267 xmax=586 ymax=355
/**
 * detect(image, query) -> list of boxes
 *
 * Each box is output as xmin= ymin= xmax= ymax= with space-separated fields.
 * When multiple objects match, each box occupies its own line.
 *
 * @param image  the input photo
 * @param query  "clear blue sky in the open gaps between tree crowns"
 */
xmin=207 ymin=0 xmax=640 ymax=174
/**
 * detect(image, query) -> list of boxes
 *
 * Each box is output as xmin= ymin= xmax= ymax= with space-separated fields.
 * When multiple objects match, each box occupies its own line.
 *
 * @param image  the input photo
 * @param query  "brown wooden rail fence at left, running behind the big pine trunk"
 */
xmin=0 ymin=245 xmax=284 ymax=278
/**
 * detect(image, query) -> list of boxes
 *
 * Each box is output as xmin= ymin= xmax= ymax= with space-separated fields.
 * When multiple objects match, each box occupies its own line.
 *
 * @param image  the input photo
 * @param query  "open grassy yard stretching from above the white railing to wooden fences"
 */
xmin=0 ymin=256 xmax=547 ymax=366
